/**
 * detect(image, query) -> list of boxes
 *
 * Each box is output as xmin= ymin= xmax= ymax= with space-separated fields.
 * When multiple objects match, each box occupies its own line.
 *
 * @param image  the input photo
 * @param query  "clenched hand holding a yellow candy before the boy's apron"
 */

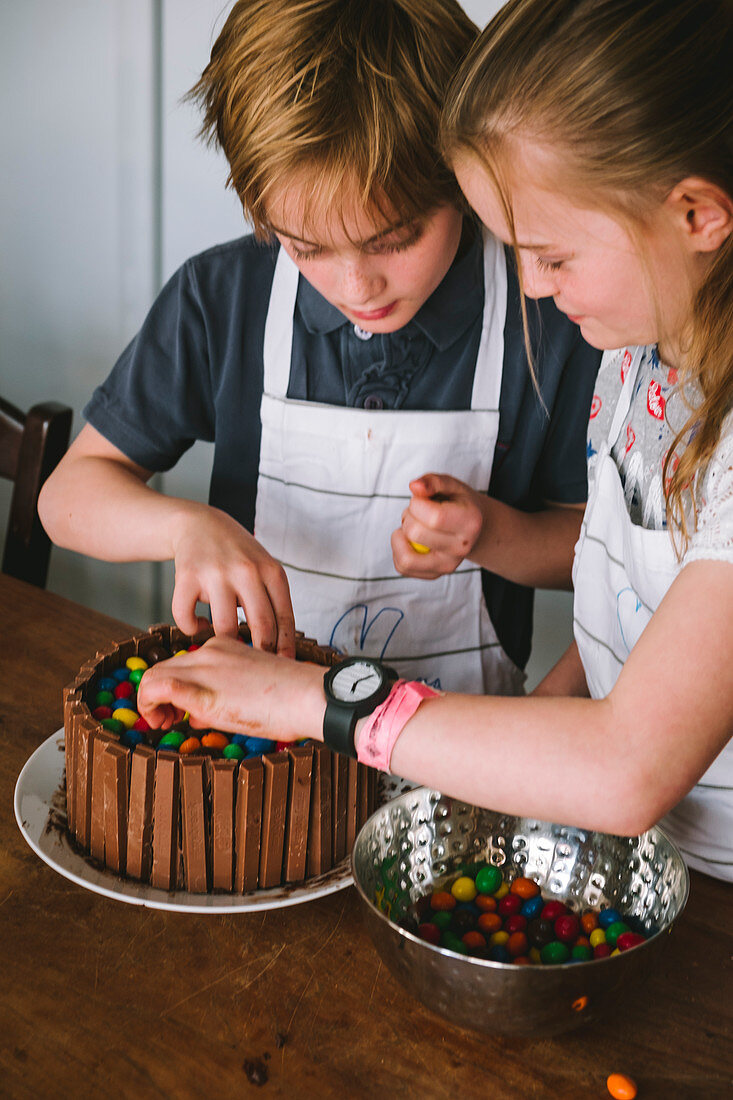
xmin=392 ymin=474 xmax=486 ymax=581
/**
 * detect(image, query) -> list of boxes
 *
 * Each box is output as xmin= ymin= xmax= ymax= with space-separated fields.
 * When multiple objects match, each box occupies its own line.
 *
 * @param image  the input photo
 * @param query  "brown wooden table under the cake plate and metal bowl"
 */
xmin=0 ymin=576 xmax=733 ymax=1100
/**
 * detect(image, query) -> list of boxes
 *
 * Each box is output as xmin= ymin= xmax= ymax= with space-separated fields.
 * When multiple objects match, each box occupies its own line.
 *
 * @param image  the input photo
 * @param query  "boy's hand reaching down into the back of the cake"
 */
xmin=172 ymin=503 xmax=295 ymax=657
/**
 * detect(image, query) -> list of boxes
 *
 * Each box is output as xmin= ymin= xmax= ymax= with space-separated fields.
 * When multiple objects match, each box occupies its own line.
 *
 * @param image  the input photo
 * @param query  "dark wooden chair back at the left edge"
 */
xmin=0 ymin=397 xmax=73 ymax=589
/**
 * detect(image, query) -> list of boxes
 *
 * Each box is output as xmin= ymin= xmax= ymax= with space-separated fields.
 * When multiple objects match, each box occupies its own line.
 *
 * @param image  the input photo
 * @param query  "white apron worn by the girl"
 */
xmin=572 ymin=348 xmax=733 ymax=881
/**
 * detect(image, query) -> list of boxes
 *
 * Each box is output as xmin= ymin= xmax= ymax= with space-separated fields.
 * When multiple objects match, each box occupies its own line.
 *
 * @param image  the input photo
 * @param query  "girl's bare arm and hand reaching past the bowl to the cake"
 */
xmin=139 ymin=561 xmax=733 ymax=835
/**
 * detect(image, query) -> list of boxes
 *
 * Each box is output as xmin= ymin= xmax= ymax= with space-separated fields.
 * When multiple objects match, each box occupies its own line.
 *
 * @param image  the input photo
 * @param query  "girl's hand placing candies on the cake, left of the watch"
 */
xmin=138 ymin=637 xmax=326 ymax=741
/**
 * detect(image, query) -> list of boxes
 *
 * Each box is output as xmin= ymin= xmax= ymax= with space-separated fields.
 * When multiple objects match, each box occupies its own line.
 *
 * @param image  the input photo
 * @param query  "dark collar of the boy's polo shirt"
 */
xmin=297 ymin=227 xmax=483 ymax=351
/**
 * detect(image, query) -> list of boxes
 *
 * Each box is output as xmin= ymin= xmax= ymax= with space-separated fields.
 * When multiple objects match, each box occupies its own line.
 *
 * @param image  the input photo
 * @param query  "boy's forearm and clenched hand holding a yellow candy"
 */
xmin=392 ymin=474 xmax=586 ymax=590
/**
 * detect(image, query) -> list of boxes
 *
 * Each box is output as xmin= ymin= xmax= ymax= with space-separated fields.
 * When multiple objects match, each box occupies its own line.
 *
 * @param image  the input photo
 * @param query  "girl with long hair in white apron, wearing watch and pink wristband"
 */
xmin=140 ymin=0 xmax=733 ymax=880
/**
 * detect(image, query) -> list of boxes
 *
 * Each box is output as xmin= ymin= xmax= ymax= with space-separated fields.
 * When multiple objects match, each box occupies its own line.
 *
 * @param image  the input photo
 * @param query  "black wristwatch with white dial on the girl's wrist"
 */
xmin=324 ymin=657 xmax=400 ymax=760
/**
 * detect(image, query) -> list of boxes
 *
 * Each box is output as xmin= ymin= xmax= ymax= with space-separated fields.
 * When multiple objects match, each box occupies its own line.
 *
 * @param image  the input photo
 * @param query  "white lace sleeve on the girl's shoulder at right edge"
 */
xmin=683 ymin=416 xmax=733 ymax=564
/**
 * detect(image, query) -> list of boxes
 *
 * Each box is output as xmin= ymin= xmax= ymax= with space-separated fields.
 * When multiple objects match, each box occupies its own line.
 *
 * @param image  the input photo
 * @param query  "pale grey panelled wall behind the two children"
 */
xmin=0 ymin=0 xmax=571 ymax=685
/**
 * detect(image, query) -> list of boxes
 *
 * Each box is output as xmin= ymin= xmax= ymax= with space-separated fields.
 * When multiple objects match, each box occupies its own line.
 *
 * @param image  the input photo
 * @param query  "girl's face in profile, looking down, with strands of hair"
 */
xmin=453 ymin=142 xmax=690 ymax=349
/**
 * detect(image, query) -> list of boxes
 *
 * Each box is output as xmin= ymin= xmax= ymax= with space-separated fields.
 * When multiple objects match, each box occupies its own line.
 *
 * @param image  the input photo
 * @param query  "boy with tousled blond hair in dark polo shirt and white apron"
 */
xmin=41 ymin=0 xmax=598 ymax=693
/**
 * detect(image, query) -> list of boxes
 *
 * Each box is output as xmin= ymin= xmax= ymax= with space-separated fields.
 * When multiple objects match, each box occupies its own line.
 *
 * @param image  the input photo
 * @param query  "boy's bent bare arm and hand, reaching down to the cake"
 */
xmin=39 ymin=425 xmax=295 ymax=657
